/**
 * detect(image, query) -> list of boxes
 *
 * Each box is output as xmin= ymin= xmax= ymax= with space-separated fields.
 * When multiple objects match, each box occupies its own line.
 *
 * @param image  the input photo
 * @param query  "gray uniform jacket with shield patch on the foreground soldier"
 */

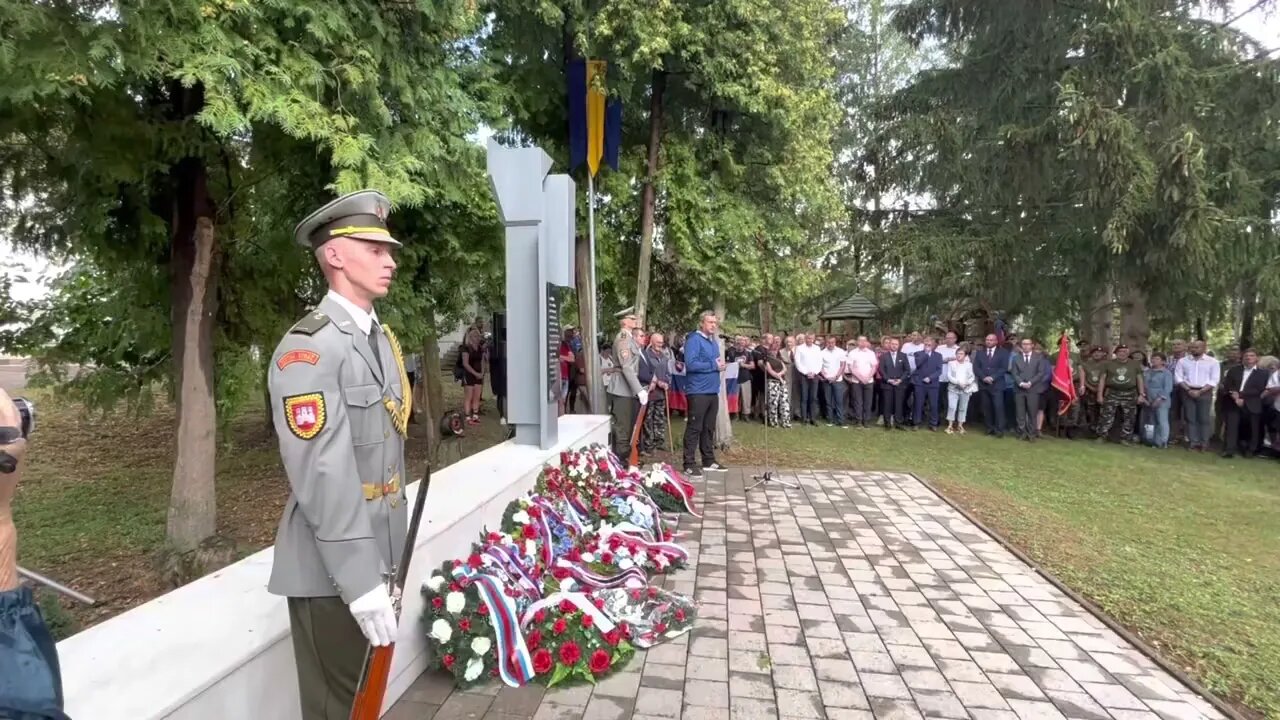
xmin=268 ymin=297 xmax=408 ymax=603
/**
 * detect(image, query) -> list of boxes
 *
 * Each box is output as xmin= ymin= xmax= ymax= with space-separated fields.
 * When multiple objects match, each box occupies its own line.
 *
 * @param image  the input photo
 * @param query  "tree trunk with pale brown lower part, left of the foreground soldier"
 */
xmin=166 ymin=147 xmax=218 ymax=552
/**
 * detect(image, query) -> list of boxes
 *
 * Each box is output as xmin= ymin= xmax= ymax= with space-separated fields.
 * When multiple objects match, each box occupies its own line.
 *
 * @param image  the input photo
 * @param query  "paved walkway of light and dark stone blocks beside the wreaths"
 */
xmin=388 ymin=470 xmax=1222 ymax=720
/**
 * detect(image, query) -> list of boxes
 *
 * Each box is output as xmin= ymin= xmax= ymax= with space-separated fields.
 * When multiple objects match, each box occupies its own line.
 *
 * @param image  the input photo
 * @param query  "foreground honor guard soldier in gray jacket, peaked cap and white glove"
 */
xmin=268 ymin=190 xmax=411 ymax=720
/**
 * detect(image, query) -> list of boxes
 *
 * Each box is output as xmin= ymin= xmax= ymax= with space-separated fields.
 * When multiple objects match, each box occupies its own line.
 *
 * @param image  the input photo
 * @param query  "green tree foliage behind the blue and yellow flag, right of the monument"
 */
xmin=483 ymin=0 xmax=844 ymax=327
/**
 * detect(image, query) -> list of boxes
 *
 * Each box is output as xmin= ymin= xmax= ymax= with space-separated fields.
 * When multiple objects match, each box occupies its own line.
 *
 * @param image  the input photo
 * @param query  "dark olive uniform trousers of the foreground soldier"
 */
xmin=289 ymin=597 xmax=369 ymax=720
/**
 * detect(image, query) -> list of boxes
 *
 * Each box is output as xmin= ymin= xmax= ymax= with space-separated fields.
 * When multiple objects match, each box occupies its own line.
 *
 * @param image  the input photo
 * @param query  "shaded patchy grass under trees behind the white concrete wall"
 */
xmin=14 ymin=384 xmax=506 ymax=637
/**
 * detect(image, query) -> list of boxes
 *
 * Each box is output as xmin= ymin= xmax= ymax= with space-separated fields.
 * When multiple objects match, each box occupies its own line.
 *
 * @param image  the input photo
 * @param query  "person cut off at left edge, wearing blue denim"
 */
xmin=0 ymin=389 xmax=67 ymax=720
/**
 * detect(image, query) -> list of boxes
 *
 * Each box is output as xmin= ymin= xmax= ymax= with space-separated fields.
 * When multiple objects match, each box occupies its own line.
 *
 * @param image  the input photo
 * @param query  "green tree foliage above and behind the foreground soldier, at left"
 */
xmin=0 ymin=0 xmax=500 ymax=419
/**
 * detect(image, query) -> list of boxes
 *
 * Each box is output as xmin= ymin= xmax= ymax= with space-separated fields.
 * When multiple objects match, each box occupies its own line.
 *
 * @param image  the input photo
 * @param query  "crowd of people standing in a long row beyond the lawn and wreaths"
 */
xmin=568 ymin=313 xmax=1280 ymax=474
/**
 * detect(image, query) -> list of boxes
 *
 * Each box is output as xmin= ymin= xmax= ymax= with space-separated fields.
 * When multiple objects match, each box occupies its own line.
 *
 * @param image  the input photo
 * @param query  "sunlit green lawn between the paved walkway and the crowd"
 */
xmin=726 ymin=423 xmax=1280 ymax=717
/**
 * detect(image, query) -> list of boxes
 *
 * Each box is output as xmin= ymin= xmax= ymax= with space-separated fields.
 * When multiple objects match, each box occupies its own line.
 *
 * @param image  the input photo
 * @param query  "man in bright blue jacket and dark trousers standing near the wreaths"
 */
xmin=685 ymin=310 xmax=724 ymax=477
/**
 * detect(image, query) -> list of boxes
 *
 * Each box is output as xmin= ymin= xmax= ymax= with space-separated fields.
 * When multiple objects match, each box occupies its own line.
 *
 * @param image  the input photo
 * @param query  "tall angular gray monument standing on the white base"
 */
xmin=488 ymin=138 xmax=576 ymax=450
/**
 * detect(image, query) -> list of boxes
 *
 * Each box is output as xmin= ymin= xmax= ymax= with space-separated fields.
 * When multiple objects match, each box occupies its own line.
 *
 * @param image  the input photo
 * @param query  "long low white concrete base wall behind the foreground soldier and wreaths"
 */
xmin=58 ymin=415 xmax=609 ymax=720
